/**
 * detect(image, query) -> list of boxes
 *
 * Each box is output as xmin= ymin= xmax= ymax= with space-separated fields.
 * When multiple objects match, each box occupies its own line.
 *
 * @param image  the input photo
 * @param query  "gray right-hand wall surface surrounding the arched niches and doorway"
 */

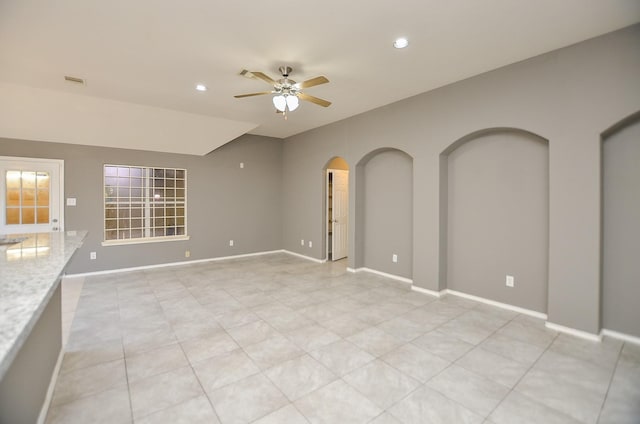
xmin=283 ymin=25 xmax=640 ymax=333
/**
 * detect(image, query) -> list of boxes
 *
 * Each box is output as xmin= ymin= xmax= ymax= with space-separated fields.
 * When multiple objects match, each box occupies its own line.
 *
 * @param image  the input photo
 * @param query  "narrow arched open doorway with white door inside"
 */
xmin=325 ymin=157 xmax=349 ymax=261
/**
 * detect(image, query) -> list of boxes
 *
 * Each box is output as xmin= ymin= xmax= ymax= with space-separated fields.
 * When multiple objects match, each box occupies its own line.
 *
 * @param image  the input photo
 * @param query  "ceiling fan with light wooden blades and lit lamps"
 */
xmin=234 ymin=66 xmax=331 ymax=118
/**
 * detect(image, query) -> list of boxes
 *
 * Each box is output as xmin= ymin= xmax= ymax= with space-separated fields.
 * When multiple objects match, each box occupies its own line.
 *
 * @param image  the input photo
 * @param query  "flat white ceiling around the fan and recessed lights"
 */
xmin=0 ymin=0 xmax=640 ymax=151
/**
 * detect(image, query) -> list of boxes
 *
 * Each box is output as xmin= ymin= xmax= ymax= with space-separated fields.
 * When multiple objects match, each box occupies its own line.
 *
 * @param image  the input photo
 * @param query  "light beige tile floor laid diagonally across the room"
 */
xmin=47 ymin=254 xmax=640 ymax=424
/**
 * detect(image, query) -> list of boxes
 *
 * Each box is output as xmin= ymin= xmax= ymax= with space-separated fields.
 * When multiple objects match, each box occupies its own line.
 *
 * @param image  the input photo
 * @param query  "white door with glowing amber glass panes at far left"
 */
xmin=0 ymin=156 xmax=64 ymax=234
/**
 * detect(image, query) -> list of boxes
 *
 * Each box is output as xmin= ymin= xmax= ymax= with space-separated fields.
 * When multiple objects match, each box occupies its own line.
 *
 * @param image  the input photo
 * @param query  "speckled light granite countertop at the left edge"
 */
xmin=0 ymin=231 xmax=87 ymax=379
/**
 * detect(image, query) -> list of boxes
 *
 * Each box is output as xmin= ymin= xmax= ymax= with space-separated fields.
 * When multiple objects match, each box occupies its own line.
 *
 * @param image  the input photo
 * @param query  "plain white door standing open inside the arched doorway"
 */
xmin=330 ymin=169 xmax=349 ymax=261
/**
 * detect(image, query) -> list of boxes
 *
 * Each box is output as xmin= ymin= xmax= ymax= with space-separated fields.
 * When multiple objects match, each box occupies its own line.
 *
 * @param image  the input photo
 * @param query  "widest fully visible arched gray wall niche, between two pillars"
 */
xmin=439 ymin=127 xmax=549 ymax=313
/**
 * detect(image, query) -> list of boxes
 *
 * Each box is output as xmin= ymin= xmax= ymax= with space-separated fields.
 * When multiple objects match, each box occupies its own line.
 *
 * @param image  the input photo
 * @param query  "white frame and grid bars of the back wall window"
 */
xmin=102 ymin=164 xmax=189 ymax=246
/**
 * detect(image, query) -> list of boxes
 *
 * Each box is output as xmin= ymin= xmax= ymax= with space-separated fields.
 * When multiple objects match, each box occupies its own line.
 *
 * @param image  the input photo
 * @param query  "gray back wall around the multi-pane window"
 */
xmin=0 ymin=135 xmax=282 ymax=274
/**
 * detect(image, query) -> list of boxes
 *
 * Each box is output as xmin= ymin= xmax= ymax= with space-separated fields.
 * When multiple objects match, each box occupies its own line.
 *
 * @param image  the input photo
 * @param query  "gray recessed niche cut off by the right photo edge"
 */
xmin=602 ymin=115 xmax=640 ymax=337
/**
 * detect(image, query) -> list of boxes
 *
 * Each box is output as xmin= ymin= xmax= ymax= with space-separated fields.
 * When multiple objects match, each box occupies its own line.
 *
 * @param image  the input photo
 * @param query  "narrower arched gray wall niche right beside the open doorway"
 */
xmin=354 ymin=148 xmax=413 ymax=279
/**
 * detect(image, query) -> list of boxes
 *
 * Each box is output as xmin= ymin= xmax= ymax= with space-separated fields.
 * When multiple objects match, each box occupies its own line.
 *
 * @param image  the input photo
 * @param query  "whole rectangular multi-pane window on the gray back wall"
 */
xmin=103 ymin=165 xmax=188 ymax=244
